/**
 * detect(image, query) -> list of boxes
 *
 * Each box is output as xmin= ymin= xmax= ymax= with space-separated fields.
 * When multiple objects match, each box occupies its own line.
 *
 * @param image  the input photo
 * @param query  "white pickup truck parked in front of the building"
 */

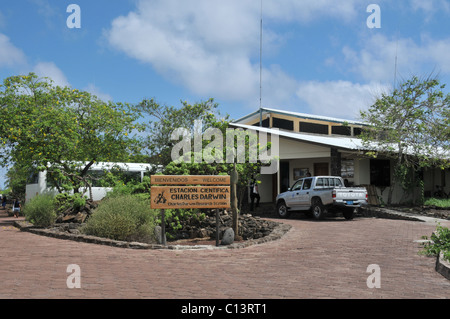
xmin=276 ymin=176 xmax=368 ymax=219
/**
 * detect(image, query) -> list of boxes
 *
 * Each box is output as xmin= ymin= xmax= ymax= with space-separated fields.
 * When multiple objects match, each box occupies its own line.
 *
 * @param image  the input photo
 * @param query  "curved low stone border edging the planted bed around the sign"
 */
xmin=14 ymin=221 xmax=292 ymax=250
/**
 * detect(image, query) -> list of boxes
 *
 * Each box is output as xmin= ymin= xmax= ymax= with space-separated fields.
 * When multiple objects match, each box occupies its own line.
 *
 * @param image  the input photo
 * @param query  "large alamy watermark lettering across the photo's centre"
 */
xmin=171 ymin=120 xmax=280 ymax=174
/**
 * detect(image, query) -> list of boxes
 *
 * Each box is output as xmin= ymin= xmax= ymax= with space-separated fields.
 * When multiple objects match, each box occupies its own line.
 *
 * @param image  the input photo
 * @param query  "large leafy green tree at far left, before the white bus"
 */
xmin=0 ymin=73 xmax=140 ymax=201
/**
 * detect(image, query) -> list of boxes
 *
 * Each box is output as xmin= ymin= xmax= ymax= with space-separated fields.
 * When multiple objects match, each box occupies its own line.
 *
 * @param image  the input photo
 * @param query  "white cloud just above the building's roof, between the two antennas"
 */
xmin=297 ymin=81 xmax=389 ymax=119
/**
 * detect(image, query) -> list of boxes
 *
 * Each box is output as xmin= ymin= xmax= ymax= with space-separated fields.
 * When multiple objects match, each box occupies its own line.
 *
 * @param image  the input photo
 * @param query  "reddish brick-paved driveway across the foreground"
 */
xmin=0 ymin=212 xmax=450 ymax=299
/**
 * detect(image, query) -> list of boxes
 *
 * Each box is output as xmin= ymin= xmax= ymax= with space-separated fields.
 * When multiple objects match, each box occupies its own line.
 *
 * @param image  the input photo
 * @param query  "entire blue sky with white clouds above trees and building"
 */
xmin=0 ymin=0 xmax=450 ymax=188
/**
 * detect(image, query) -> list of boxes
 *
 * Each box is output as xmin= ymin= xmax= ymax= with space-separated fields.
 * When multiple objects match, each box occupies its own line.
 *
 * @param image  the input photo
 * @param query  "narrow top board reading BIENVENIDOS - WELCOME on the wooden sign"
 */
xmin=150 ymin=175 xmax=230 ymax=185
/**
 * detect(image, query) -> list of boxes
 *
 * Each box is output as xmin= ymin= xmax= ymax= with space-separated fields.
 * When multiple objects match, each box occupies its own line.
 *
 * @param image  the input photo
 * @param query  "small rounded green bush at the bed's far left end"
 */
xmin=23 ymin=194 xmax=56 ymax=227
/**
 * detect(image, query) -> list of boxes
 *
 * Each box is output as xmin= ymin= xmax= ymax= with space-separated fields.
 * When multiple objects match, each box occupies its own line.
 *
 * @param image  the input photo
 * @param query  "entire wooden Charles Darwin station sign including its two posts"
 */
xmin=150 ymin=175 xmax=231 ymax=246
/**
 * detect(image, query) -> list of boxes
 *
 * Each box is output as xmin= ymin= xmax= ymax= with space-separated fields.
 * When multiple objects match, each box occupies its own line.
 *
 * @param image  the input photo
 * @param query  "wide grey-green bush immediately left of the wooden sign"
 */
xmin=81 ymin=195 xmax=158 ymax=243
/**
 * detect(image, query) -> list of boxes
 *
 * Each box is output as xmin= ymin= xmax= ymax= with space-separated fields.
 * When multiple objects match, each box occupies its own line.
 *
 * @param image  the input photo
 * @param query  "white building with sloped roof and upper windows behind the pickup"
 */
xmin=230 ymin=108 xmax=450 ymax=203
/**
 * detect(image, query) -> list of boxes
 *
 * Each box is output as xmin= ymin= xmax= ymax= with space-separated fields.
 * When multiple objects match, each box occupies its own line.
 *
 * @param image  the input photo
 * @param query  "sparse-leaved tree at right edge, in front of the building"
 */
xmin=361 ymin=76 xmax=450 ymax=204
